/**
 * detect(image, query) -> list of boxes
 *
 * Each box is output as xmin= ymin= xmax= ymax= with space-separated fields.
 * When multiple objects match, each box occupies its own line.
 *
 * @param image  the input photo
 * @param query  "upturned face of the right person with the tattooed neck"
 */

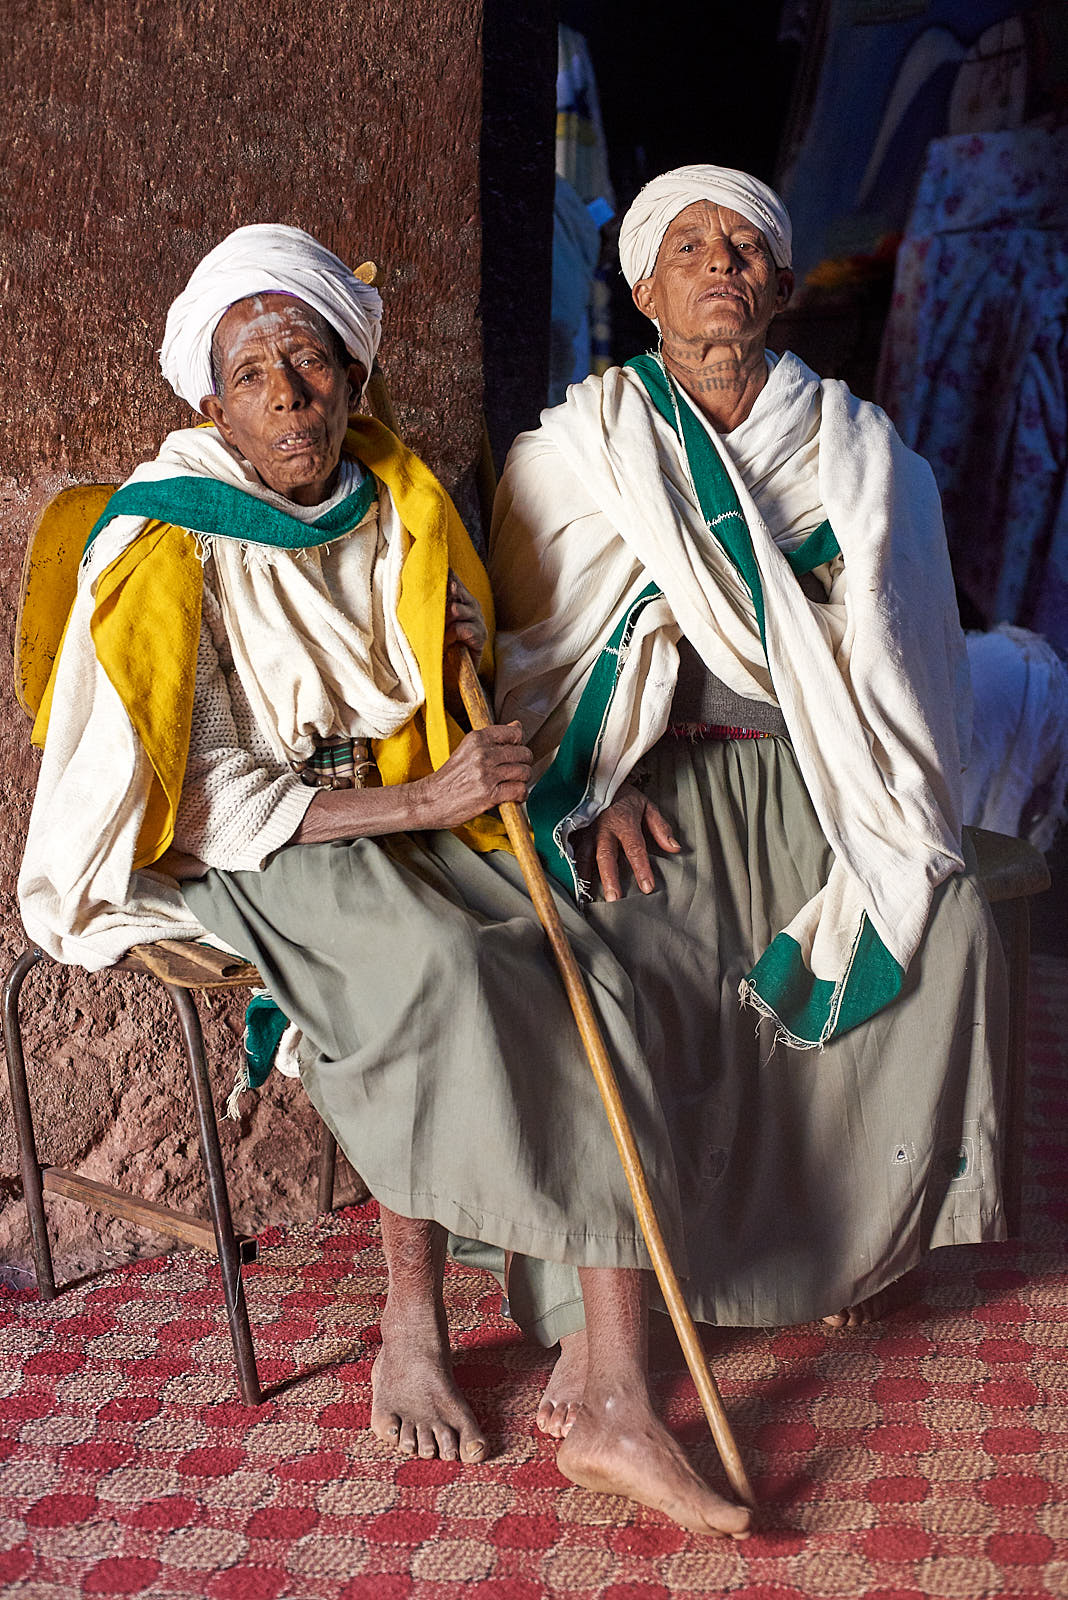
xmin=633 ymin=200 xmax=793 ymax=346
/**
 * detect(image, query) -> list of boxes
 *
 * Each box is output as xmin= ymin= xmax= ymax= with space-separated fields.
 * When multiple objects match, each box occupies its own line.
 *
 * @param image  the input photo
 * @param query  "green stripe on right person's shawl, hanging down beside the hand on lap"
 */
xmin=526 ymin=584 xmax=662 ymax=898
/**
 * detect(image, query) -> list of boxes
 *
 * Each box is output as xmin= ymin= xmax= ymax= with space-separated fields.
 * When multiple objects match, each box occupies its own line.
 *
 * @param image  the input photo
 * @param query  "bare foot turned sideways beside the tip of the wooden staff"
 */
xmin=556 ymin=1389 xmax=753 ymax=1539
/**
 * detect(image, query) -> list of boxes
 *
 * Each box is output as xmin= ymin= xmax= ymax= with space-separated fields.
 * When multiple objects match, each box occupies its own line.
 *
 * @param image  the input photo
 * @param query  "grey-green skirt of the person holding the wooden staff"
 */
xmin=187 ymin=812 xmax=681 ymax=1267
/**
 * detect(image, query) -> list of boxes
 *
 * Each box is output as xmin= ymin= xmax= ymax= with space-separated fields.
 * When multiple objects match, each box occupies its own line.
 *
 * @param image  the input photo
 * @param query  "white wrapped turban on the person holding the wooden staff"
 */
xmin=160 ymin=222 xmax=382 ymax=411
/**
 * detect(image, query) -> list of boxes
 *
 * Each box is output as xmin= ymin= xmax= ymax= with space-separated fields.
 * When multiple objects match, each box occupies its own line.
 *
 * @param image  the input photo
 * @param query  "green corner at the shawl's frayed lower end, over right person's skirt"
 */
xmin=747 ymin=912 xmax=905 ymax=1048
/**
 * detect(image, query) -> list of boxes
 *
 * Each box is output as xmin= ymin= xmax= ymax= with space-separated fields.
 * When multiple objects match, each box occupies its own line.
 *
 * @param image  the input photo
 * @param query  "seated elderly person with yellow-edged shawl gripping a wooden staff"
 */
xmin=19 ymin=226 xmax=750 ymax=1536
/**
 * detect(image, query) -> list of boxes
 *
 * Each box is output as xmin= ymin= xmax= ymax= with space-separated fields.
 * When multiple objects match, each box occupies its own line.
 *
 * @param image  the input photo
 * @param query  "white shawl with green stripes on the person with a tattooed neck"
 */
xmin=491 ymin=355 xmax=969 ymax=1046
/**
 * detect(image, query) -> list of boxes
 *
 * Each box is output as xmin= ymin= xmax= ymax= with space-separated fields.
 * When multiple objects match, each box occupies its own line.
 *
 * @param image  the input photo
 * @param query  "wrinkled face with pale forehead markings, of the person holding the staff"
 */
xmin=200 ymin=294 xmax=366 ymax=506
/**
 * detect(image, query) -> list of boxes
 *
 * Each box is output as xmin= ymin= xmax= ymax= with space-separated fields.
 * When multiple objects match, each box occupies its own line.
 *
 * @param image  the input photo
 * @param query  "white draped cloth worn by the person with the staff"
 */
xmin=19 ymin=429 xmax=422 ymax=971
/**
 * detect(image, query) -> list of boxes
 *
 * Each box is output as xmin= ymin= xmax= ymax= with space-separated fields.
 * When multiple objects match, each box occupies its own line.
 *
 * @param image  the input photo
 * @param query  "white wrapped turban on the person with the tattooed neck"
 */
xmin=619 ymin=166 xmax=793 ymax=290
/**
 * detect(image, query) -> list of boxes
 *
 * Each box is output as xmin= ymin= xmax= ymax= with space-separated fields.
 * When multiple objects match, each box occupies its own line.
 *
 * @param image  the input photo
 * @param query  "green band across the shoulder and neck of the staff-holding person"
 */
xmin=85 ymin=472 xmax=376 ymax=550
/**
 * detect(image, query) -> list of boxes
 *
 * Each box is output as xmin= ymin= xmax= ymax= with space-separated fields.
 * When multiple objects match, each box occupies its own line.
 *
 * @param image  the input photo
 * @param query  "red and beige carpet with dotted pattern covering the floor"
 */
xmin=0 ymin=957 xmax=1068 ymax=1600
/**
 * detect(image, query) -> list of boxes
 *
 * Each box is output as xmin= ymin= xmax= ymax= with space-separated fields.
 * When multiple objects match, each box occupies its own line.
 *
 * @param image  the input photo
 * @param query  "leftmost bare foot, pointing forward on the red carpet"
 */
xmin=371 ymin=1333 xmax=486 ymax=1461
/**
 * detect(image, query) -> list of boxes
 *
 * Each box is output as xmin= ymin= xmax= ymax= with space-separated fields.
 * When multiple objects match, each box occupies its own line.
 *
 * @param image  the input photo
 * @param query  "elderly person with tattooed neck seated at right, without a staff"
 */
xmin=489 ymin=166 xmax=1004 ymax=1438
